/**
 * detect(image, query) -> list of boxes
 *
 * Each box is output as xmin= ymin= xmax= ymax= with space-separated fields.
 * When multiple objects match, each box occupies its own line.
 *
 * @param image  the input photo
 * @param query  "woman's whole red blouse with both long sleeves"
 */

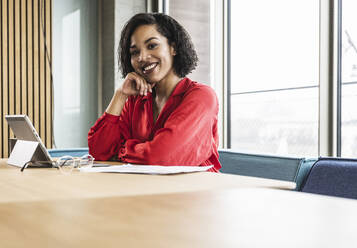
xmin=88 ymin=78 xmax=221 ymax=172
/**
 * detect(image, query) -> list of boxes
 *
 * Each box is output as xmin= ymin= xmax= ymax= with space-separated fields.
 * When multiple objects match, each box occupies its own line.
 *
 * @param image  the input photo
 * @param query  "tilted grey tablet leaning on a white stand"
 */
xmin=5 ymin=115 xmax=52 ymax=161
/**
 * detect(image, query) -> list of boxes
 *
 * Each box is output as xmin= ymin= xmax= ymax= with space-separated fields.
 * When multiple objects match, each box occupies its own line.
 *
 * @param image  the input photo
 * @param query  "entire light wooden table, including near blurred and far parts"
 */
xmin=0 ymin=160 xmax=357 ymax=248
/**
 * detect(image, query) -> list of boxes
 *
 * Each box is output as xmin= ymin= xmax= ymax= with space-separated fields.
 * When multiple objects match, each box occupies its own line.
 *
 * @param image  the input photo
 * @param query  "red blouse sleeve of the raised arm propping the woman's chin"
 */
xmin=88 ymin=99 xmax=131 ymax=160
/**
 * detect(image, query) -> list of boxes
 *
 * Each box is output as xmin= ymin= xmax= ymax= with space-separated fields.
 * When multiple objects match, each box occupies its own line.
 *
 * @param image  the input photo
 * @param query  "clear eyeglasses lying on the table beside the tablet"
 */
xmin=21 ymin=154 xmax=94 ymax=174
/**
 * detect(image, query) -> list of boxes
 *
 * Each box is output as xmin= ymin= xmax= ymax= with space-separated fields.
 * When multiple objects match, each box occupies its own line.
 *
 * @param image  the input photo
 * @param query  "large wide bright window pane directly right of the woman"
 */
xmin=229 ymin=0 xmax=319 ymax=156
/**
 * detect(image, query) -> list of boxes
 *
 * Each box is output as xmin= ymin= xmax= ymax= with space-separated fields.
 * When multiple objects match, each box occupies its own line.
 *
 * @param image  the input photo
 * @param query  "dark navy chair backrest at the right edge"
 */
xmin=301 ymin=158 xmax=357 ymax=199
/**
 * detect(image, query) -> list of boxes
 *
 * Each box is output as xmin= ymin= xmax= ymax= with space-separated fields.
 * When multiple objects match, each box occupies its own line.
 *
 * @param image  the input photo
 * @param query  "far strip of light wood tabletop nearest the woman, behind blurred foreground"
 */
xmin=0 ymin=160 xmax=296 ymax=202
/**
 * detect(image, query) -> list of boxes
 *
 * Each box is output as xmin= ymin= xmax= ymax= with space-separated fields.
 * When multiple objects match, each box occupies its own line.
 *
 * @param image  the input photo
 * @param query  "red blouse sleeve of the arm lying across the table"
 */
xmin=118 ymin=86 xmax=218 ymax=165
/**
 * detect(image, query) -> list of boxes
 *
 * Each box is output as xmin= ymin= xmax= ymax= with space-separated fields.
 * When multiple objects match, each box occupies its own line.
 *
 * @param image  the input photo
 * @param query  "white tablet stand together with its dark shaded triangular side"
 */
xmin=7 ymin=140 xmax=47 ymax=167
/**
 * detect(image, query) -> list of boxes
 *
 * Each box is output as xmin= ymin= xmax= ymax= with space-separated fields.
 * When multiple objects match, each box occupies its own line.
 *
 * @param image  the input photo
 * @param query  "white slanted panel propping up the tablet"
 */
xmin=7 ymin=140 xmax=38 ymax=167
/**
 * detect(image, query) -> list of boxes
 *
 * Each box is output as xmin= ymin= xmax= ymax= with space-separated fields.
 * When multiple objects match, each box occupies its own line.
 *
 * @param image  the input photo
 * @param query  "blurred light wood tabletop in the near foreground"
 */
xmin=0 ymin=188 xmax=357 ymax=248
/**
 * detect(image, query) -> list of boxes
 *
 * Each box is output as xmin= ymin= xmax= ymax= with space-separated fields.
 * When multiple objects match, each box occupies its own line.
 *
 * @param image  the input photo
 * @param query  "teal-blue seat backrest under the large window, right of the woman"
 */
xmin=218 ymin=149 xmax=316 ymax=190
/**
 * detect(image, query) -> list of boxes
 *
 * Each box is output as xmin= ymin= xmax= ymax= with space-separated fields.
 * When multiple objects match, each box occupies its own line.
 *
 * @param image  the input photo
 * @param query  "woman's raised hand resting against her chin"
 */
xmin=118 ymin=72 xmax=155 ymax=96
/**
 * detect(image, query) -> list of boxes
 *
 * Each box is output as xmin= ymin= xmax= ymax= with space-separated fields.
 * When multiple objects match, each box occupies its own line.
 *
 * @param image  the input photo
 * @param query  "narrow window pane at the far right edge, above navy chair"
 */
xmin=341 ymin=0 xmax=357 ymax=157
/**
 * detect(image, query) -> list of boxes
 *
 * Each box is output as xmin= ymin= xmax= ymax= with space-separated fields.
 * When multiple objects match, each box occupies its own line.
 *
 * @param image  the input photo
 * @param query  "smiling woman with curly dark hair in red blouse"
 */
xmin=88 ymin=13 xmax=221 ymax=172
